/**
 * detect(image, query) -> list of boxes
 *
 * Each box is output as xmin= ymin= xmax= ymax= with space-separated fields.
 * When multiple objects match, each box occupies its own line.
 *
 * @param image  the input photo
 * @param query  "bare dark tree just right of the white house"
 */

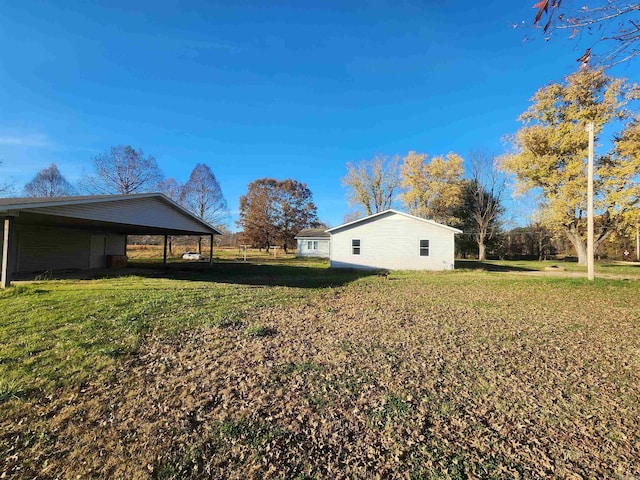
xmin=464 ymin=152 xmax=506 ymax=261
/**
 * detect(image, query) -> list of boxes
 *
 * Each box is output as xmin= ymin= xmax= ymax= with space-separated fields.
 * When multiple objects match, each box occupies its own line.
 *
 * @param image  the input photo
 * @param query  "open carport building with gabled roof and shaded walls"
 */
xmin=0 ymin=193 xmax=220 ymax=288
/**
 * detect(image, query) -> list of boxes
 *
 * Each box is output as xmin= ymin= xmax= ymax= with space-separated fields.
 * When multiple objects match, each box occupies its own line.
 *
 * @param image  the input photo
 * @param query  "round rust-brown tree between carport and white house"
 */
xmin=238 ymin=178 xmax=320 ymax=252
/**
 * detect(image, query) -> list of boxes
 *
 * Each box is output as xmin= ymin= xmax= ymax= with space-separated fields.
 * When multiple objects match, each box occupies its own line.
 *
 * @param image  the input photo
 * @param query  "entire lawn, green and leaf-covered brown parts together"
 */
xmin=0 ymin=260 xmax=640 ymax=479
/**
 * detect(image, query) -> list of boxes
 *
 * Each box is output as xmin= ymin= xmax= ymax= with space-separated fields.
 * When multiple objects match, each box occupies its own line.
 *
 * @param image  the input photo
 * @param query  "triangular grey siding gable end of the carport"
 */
xmin=24 ymin=197 xmax=211 ymax=234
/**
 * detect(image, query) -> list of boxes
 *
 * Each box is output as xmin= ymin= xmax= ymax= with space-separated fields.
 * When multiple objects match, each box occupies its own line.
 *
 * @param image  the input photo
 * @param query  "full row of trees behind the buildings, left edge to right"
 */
xmin=0 ymin=65 xmax=640 ymax=264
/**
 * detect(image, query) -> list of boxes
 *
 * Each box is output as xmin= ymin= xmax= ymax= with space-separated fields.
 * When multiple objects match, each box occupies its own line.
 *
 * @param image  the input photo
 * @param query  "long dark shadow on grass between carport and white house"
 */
xmin=15 ymin=262 xmax=377 ymax=288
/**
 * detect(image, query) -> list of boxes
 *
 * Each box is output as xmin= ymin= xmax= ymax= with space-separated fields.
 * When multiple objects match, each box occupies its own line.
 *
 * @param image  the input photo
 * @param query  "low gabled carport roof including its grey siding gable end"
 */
xmin=0 ymin=193 xmax=221 ymax=235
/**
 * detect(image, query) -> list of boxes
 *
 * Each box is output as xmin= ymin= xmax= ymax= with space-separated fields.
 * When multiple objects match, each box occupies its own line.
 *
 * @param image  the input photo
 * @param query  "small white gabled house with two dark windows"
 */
xmin=327 ymin=210 xmax=462 ymax=270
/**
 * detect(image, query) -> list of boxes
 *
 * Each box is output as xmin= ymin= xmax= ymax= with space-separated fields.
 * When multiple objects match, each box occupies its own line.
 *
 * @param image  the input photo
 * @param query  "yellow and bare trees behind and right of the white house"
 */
xmin=343 ymin=65 xmax=640 ymax=264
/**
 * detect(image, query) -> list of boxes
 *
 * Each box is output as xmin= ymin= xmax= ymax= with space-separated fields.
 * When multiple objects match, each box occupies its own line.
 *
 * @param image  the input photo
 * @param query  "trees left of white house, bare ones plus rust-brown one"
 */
xmin=0 ymin=145 xmax=321 ymax=252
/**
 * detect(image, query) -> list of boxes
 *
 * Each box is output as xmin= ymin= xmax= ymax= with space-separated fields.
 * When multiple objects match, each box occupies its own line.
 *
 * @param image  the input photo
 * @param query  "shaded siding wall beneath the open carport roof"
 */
xmin=14 ymin=225 xmax=125 ymax=273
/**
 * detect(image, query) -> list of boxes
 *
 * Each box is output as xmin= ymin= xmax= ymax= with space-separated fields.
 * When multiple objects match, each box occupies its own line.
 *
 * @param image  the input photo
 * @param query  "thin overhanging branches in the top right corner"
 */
xmin=534 ymin=0 xmax=640 ymax=66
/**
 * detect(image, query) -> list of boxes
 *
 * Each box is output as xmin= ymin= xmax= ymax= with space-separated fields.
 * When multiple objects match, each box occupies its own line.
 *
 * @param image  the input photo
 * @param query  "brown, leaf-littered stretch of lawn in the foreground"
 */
xmin=0 ymin=273 xmax=640 ymax=478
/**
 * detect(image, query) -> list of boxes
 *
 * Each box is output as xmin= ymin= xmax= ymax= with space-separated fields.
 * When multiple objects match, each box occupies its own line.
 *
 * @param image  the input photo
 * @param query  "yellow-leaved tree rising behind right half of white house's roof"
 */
xmin=400 ymin=151 xmax=464 ymax=226
